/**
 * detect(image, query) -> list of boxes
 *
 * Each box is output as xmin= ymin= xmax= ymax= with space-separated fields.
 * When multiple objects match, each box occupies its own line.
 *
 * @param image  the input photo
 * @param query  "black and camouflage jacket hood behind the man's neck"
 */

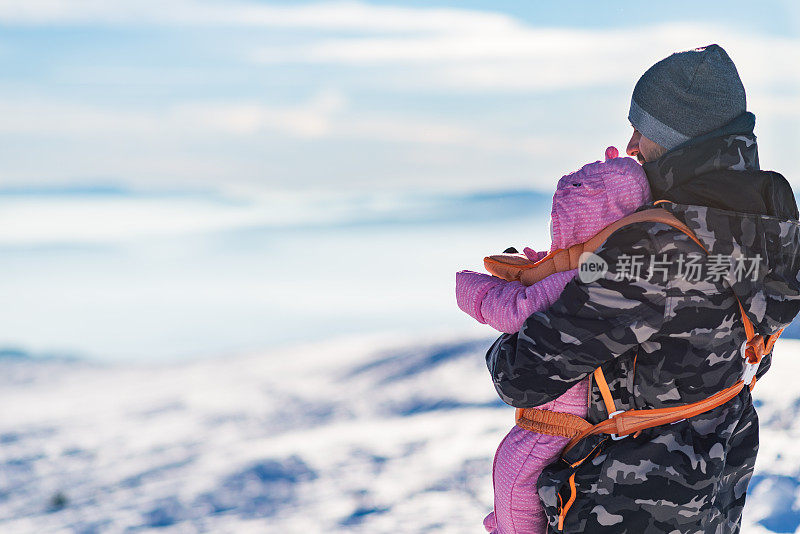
xmin=643 ymin=113 xmax=800 ymax=334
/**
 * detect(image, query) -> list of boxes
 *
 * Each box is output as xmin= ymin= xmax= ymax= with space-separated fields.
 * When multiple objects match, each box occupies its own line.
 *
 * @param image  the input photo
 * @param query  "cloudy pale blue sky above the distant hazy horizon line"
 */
xmin=0 ymin=0 xmax=800 ymax=196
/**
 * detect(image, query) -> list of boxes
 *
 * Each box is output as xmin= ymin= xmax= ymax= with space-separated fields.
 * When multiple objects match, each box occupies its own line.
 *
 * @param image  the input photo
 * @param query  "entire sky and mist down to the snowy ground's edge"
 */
xmin=0 ymin=0 xmax=800 ymax=360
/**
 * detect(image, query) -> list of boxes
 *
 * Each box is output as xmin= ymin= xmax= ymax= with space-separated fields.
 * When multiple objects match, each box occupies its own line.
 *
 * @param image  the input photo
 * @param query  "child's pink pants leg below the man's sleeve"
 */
xmin=483 ymin=378 xmax=589 ymax=534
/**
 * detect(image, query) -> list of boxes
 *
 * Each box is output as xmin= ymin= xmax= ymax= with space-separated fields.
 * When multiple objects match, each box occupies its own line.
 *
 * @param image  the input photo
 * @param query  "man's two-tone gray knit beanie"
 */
xmin=628 ymin=44 xmax=746 ymax=150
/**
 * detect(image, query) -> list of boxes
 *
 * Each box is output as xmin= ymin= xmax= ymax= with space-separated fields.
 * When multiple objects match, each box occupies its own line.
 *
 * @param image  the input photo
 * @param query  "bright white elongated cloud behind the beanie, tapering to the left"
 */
xmin=249 ymin=21 xmax=800 ymax=92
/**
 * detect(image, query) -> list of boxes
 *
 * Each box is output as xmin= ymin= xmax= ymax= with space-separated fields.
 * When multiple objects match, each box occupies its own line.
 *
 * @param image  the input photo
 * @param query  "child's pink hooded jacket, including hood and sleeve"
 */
xmin=456 ymin=147 xmax=650 ymax=333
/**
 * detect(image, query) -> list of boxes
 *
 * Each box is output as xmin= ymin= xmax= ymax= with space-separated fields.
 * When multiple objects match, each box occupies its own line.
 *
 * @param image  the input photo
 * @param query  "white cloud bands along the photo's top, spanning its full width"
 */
xmin=0 ymin=0 xmax=800 ymax=92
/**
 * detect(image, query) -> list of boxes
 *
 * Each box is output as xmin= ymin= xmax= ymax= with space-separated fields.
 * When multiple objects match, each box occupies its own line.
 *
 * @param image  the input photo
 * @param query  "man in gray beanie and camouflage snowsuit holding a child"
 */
xmin=486 ymin=45 xmax=800 ymax=534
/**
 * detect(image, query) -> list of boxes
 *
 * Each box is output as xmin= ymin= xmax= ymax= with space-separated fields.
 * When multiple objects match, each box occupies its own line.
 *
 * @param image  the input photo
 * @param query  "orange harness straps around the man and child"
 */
xmin=484 ymin=205 xmax=783 ymax=530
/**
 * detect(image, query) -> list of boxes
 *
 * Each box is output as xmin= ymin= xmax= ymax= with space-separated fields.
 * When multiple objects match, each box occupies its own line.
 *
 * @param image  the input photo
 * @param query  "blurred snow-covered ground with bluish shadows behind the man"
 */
xmin=0 ymin=335 xmax=800 ymax=534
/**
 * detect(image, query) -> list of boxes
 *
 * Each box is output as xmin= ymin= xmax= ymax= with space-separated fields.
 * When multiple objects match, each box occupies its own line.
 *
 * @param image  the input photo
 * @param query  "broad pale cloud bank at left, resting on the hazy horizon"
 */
xmin=0 ymin=88 xmax=555 ymax=197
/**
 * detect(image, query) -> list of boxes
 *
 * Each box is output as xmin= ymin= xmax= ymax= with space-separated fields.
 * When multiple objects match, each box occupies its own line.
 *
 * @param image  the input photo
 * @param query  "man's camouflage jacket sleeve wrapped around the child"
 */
xmin=486 ymin=222 xmax=677 ymax=408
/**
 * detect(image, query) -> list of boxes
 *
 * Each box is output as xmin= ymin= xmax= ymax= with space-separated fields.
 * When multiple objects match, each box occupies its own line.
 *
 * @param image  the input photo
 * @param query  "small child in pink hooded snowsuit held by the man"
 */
xmin=456 ymin=147 xmax=650 ymax=534
